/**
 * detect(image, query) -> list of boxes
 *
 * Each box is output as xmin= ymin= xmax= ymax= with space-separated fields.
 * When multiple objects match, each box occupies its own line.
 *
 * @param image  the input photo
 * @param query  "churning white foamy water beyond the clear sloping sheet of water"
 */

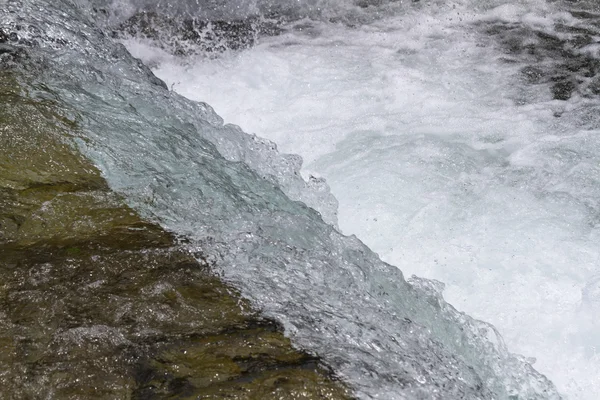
xmin=124 ymin=1 xmax=600 ymax=400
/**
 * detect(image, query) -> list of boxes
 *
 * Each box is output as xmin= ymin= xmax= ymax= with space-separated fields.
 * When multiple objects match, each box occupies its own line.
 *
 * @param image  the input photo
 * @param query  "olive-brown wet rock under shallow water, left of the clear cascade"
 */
xmin=0 ymin=70 xmax=349 ymax=399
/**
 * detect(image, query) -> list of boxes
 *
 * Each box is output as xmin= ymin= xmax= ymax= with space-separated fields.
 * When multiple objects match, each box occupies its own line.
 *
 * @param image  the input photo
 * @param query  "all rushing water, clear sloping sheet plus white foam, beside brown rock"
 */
xmin=0 ymin=0 xmax=600 ymax=399
